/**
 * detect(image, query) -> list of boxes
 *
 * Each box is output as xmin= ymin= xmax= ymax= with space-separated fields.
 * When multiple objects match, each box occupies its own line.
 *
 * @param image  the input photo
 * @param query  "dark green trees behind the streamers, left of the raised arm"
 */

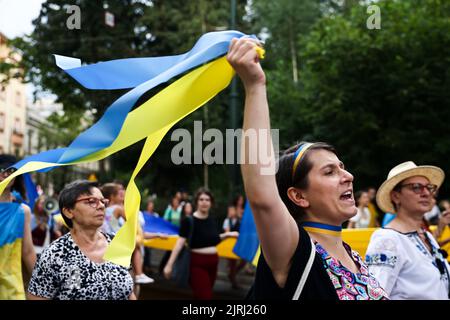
xmin=14 ymin=0 xmax=250 ymax=215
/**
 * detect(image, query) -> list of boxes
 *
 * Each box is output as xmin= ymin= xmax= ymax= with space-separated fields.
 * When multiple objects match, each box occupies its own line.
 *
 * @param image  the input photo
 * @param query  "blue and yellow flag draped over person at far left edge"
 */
xmin=0 ymin=202 xmax=25 ymax=300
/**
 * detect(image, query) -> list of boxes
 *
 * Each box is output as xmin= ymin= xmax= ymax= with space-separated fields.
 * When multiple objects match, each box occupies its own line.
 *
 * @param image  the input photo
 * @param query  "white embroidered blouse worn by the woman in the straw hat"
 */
xmin=366 ymin=229 xmax=450 ymax=300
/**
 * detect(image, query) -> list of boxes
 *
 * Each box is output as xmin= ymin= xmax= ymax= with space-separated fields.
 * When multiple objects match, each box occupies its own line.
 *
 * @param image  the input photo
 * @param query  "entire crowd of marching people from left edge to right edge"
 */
xmin=0 ymin=38 xmax=450 ymax=300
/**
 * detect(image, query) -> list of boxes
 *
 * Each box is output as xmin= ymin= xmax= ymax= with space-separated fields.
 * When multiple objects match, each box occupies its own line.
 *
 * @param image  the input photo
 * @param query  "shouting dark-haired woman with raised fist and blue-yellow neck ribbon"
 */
xmin=227 ymin=39 xmax=386 ymax=300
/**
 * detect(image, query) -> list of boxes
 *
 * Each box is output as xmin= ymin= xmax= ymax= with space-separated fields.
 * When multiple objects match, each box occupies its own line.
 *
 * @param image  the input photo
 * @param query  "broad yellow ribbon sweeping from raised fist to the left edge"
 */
xmin=0 ymin=58 xmax=234 ymax=194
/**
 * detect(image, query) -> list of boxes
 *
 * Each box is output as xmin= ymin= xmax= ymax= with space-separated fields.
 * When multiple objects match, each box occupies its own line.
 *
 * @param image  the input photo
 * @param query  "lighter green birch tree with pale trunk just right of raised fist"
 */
xmin=249 ymin=0 xmax=329 ymax=150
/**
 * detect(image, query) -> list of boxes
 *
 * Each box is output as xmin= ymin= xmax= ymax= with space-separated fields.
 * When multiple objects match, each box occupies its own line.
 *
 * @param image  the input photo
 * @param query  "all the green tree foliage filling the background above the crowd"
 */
xmin=13 ymin=0 xmax=450 ymax=213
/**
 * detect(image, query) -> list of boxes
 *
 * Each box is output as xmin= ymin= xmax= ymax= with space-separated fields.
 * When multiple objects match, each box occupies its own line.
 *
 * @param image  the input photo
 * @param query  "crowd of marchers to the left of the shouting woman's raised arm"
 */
xmin=0 ymin=155 xmax=244 ymax=299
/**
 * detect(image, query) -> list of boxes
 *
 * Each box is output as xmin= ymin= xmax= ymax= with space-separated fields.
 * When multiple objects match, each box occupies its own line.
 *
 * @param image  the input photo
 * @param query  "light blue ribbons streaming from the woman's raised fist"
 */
xmin=9 ymin=31 xmax=256 ymax=171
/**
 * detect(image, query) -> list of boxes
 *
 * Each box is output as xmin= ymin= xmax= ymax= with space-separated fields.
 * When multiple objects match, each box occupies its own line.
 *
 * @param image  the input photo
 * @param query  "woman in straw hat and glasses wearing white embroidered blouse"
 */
xmin=366 ymin=161 xmax=449 ymax=299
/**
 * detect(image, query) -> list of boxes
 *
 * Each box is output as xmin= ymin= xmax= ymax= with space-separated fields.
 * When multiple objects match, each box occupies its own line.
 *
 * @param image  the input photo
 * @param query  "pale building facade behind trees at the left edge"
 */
xmin=0 ymin=32 xmax=99 ymax=195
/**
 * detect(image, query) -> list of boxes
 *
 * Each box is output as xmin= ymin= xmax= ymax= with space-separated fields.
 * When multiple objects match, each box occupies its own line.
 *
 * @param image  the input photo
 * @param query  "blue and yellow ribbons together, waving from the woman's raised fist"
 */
xmin=0 ymin=31 xmax=264 ymax=267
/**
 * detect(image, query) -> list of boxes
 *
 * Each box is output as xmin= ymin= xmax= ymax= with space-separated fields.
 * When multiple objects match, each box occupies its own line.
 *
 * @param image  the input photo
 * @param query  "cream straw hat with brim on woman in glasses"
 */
xmin=377 ymin=161 xmax=445 ymax=213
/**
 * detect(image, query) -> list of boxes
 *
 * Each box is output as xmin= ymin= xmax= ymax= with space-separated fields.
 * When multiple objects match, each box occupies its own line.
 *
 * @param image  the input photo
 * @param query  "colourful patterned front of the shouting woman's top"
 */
xmin=315 ymin=243 xmax=388 ymax=300
